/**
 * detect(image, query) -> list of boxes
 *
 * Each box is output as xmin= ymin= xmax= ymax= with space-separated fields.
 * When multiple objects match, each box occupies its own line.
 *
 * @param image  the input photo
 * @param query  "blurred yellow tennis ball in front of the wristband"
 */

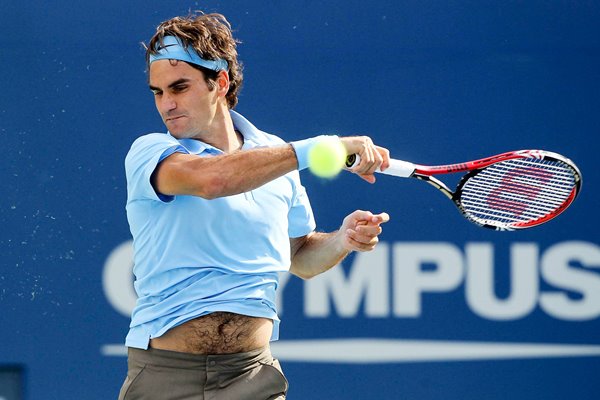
xmin=308 ymin=137 xmax=346 ymax=178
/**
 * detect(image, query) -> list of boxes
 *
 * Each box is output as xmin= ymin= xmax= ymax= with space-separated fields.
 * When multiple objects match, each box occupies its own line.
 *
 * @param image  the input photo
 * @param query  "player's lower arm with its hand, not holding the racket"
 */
xmin=290 ymin=210 xmax=390 ymax=279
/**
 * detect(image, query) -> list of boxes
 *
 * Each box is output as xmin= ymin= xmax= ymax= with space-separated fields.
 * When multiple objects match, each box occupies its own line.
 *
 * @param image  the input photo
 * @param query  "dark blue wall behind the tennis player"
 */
xmin=0 ymin=0 xmax=600 ymax=400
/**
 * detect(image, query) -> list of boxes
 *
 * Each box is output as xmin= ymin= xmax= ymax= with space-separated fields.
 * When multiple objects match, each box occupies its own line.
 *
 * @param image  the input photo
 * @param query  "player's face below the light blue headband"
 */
xmin=149 ymin=60 xmax=218 ymax=139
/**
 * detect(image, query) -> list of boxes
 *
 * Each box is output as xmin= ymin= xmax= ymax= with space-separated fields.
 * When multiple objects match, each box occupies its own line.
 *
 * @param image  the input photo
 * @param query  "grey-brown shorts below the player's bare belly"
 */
xmin=119 ymin=346 xmax=288 ymax=400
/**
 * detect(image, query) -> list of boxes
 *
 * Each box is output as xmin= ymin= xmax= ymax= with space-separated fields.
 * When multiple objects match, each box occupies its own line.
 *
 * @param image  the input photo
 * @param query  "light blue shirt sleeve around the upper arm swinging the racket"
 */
xmin=125 ymin=133 xmax=189 ymax=202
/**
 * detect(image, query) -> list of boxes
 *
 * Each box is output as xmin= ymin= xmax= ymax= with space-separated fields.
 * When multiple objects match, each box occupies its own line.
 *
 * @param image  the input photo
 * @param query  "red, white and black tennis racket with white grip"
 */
xmin=346 ymin=150 xmax=581 ymax=230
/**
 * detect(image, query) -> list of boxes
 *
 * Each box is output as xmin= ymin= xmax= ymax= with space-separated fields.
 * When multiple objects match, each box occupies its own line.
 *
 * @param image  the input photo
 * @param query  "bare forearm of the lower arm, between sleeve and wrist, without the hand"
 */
xmin=290 ymin=231 xmax=350 ymax=279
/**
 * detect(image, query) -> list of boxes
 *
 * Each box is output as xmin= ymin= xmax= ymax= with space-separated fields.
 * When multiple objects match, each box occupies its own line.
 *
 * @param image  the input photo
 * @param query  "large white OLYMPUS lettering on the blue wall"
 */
xmin=103 ymin=241 xmax=600 ymax=321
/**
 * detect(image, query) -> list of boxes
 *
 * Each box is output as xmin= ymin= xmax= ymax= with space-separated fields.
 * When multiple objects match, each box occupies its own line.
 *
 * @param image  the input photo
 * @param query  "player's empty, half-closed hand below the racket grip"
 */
xmin=338 ymin=210 xmax=390 ymax=251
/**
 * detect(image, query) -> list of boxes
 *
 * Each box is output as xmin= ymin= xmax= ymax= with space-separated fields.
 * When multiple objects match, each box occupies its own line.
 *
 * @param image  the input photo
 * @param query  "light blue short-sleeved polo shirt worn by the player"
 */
xmin=125 ymin=111 xmax=315 ymax=349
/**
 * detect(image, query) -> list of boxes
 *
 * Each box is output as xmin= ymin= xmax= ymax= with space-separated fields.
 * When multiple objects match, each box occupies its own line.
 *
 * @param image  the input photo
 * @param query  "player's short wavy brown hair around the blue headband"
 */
xmin=145 ymin=12 xmax=244 ymax=109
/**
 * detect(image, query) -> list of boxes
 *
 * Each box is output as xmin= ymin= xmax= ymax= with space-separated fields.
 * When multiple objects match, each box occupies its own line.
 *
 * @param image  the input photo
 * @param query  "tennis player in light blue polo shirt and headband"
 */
xmin=119 ymin=14 xmax=389 ymax=400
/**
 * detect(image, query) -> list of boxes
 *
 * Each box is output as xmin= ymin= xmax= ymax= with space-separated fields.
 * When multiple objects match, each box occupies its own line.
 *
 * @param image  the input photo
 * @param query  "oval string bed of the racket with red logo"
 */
xmin=460 ymin=158 xmax=576 ymax=227
